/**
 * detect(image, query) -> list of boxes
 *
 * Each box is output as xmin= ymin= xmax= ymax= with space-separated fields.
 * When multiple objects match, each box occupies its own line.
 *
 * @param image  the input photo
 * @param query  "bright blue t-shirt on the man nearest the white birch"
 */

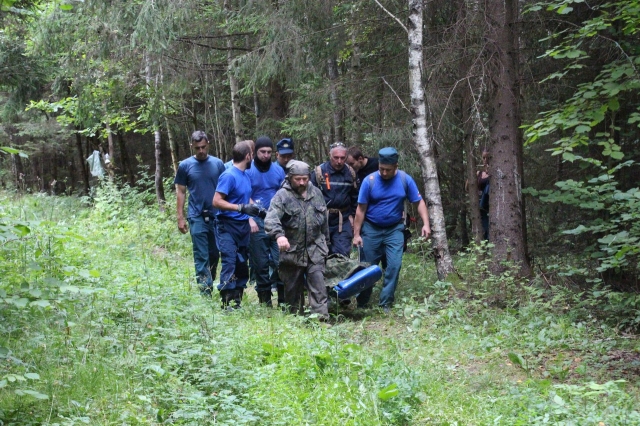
xmin=358 ymin=170 xmax=422 ymax=226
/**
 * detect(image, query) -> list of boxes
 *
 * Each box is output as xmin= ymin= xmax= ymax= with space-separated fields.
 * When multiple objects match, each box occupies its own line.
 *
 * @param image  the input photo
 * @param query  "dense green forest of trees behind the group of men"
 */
xmin=0 ymin=0 xmax=640 ymax=300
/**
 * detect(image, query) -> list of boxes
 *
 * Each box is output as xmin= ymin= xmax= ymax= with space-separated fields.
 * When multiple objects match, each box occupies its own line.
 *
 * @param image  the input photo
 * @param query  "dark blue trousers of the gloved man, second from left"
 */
xmin=216 ymin=218 xmax=251 ymax=290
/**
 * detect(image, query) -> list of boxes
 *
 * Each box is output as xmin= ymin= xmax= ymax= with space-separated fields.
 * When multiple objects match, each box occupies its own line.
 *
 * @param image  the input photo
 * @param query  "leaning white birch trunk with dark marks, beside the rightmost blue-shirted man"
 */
xmin=407 ymin=0 xmax=453 ymax=280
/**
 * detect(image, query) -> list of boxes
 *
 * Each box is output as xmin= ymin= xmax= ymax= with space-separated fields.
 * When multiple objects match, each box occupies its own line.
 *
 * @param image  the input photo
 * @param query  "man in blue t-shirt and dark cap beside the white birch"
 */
xmin=353 ymin=147 xmax=431 ymax=312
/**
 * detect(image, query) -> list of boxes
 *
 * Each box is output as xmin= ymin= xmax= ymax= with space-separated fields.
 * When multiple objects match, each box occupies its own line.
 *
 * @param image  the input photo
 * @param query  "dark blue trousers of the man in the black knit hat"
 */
xmin=249 ymin=217 xmax=282 ymax=292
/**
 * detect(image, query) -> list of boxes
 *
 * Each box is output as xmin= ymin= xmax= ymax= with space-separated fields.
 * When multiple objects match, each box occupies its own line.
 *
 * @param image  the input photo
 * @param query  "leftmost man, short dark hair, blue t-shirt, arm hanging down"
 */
xmin=173 ymin=130 xmax=224 ymax=296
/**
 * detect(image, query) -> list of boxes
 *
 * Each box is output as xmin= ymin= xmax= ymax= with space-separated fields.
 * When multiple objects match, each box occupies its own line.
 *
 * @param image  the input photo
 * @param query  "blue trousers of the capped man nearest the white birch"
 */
xmin=357 ymin=221 xmax=404 ymax=307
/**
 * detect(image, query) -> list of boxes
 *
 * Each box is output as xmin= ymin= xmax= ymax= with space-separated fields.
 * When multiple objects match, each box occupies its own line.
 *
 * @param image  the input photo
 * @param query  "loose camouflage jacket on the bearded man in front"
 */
xmin=264 ymin=180 xmax=329 ymax=266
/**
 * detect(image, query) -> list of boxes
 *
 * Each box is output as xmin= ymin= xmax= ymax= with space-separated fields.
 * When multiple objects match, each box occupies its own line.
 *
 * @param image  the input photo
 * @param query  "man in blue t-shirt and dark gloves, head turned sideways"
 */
xmin=213 ymin=141 xmax=260 ymax=309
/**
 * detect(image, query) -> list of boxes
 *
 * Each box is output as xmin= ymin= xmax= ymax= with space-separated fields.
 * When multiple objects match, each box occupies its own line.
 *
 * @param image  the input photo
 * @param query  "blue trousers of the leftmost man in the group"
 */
xmin=189 ymin=216 xmax=220 ymax=294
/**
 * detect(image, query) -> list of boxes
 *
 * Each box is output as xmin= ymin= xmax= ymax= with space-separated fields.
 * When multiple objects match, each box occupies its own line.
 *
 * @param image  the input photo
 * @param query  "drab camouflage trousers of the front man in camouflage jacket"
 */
xmin=279 ymin=263 xmax=329 ymax=318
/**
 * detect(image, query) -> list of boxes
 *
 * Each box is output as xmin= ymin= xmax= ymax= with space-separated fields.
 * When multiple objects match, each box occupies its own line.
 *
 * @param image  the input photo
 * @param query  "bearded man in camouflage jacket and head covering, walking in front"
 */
xmin=264 ymin=160 xmax=329 ymax=318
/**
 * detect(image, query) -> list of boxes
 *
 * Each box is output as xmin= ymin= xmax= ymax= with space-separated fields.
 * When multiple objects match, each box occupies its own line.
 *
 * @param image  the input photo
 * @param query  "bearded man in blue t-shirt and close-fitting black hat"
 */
xmin=246 ymin=136 xmax=285 ymax=306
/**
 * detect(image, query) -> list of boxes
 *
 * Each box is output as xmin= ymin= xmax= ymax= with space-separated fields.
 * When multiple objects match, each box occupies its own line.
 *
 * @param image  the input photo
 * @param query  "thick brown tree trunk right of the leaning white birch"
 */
xmin=485 ymin=0 xmax=531 ymax=276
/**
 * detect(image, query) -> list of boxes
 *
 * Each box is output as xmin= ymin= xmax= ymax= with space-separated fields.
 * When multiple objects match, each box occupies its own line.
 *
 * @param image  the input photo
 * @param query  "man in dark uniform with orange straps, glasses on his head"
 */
xmin=311 ymin=142 xmax=358 ymax=256
